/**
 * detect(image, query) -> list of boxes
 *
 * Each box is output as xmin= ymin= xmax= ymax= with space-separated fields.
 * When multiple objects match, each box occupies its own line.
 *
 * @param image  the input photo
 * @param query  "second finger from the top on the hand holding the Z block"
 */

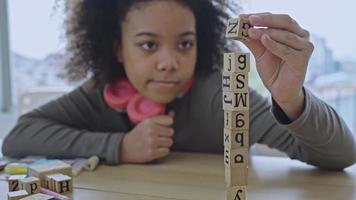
xmin=248 ymin=28 xmax=311 ymax=51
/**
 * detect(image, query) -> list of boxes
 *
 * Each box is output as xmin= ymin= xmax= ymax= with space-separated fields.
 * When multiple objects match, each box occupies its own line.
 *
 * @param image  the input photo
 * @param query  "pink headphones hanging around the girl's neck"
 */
xmin=104 ymin=79 xmax=193 ymax=124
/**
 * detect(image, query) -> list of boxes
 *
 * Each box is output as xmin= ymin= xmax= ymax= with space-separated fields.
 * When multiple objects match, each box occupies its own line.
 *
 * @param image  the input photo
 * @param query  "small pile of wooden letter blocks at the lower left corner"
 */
xmin=8 ymin=160 xmax=73 ymax=200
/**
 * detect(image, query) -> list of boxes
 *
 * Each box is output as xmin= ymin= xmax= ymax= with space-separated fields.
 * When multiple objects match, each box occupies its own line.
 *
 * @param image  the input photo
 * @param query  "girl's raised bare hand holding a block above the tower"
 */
xmin=240 ymin=13 xmax=314 ymax=120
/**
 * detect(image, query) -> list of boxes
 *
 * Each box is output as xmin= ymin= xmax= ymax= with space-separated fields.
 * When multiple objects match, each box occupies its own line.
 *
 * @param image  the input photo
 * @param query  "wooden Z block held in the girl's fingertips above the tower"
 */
xmin=225 ymin=18 xmax=251 ymax=40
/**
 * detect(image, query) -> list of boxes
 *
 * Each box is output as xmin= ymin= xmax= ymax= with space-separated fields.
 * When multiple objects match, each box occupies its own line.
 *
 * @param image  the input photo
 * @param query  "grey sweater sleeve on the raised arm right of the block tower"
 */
xmin=252 ymin=86 xmax=356 ymax=169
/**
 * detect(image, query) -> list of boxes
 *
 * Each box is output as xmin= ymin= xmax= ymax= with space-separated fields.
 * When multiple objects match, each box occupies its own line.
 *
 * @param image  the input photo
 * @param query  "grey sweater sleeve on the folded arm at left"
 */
xmin=2 ymin=82 xmax=129 ymax=164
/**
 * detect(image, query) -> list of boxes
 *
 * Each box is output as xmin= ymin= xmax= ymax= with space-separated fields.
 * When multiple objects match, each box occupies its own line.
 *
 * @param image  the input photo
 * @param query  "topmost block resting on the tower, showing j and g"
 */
xmin=223 ymin=52 xmax=250 ymax=73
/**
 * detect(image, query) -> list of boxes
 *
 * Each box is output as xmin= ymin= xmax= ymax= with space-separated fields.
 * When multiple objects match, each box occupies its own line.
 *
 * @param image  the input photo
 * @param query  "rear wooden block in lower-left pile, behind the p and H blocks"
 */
xmin=28 ymin=160 xmax=72 ymax=187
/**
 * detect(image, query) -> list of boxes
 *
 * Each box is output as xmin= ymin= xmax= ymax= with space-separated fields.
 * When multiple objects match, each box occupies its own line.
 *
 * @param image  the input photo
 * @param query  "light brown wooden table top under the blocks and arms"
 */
xmin=0 ymin=153 xmax=356 ymax=200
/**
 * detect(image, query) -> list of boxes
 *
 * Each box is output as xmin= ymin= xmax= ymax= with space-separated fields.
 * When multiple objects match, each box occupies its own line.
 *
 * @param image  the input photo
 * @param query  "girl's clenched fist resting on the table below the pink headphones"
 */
xmin=120 ymin=111 xmax=174 ymax=163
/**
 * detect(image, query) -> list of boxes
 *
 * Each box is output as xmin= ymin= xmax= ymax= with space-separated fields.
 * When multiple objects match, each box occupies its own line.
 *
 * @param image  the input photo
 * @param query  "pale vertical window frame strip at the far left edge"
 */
xmin=0 ymin=0 xmax=12 ymax=113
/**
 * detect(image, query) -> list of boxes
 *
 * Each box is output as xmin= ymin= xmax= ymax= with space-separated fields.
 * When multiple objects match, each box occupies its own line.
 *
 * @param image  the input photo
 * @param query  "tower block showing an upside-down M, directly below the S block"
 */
xmin=223 ymin=91 xmax=250 ymax=111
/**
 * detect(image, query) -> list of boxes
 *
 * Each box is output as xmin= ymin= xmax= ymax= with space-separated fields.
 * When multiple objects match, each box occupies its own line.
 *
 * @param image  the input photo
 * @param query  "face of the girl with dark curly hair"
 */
xmin=116 ymin=0 xmax=197 ymax=103
